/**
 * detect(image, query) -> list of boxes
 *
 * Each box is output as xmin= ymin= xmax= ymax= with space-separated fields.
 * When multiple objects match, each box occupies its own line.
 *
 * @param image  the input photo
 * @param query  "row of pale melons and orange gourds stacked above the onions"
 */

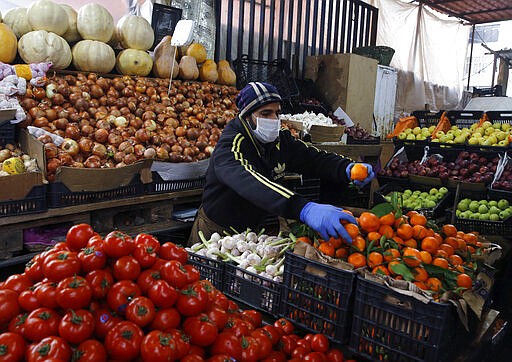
xmin=0 ymin=0 xmax=236 ymax=85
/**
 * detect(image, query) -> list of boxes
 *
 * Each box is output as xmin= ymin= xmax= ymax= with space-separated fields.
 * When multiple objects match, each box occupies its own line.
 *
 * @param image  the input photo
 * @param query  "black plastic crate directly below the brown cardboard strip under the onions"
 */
xmin=47 ymin=175 xmax=144 ymax=208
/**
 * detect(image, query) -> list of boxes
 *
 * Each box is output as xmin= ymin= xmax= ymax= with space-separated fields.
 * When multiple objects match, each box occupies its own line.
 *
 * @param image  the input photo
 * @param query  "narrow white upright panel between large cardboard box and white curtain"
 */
xmin=373 ymin=65 xmax=398 ymax=139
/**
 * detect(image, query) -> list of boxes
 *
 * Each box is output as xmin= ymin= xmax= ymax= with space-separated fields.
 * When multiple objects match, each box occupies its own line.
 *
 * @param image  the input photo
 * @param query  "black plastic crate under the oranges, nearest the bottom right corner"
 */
xmin=349 ymin=276 xmax=469 ymax=362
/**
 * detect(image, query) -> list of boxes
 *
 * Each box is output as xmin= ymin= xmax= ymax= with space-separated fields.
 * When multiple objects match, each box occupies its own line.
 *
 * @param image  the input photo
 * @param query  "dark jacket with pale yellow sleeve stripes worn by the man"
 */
xmin=202 ymin=117 xmax=352 ymax=230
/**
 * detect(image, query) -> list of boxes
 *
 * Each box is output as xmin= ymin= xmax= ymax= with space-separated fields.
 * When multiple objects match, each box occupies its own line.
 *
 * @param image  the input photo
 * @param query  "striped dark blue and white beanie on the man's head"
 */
xmin=236 ymin=82 xmax=281 ymax=118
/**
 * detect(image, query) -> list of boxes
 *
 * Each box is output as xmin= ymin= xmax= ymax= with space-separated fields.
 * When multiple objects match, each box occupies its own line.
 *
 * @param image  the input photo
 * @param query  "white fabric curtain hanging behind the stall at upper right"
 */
xmin=367 ymin=0 xmax=471 ymax=116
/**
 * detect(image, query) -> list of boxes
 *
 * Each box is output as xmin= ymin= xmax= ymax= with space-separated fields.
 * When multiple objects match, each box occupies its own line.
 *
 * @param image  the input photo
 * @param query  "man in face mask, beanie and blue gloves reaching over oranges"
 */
xmin=189 ymin=82 xmax=374 ymax=243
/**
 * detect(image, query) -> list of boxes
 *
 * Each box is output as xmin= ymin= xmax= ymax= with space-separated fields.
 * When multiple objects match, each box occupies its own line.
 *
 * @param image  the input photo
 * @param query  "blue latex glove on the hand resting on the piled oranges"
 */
xmin=300 ymin=202 xmax=357 ymax=243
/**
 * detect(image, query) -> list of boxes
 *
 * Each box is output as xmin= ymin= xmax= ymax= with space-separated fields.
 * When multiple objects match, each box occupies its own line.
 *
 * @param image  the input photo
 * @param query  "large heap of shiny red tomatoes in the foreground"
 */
xmin=0 ymin=224 xmax=352 ymax=362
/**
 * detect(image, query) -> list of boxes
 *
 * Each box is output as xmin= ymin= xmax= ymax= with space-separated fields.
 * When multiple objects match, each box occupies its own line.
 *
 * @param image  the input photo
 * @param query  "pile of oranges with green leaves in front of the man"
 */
xmin=306 ymin=211 xmax=482 ymax=298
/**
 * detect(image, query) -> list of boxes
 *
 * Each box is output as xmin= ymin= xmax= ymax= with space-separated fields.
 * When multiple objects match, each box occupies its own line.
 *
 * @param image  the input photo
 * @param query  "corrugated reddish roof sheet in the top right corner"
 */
xmin=419 ymin=0 xmax=512 ymax=24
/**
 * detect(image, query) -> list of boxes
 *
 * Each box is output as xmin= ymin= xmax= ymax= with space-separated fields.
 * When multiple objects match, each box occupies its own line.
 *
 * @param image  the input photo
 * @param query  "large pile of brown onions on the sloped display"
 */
xmin=20 ymin=73 xmax=238 ymax=181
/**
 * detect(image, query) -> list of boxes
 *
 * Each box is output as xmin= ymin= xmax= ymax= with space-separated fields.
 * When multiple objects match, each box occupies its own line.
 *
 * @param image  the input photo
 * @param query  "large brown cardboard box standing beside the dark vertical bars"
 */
xmin=305 ymin=54 xmax=378 ymax=131
